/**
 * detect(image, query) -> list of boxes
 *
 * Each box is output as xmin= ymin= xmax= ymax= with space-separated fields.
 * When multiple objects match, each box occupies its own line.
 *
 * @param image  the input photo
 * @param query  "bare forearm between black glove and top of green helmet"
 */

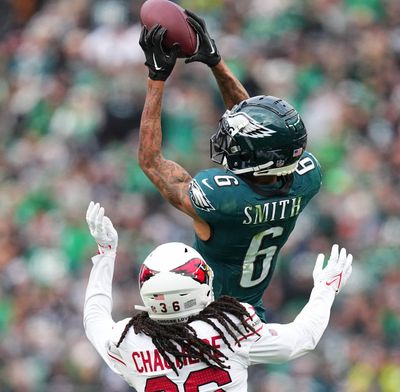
xmin=211 ymin=60 xmax=249 ymax=109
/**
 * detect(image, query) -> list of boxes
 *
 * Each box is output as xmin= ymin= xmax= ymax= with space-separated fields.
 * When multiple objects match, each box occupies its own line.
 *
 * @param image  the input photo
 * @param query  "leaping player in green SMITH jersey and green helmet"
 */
xmin=139 ymin=12 xmax=321 ymax=317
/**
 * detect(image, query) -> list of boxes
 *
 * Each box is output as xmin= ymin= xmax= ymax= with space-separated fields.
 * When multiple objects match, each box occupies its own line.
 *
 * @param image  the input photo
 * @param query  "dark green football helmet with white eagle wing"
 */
xmin=210 ymin=95 xmax=307 ymax=176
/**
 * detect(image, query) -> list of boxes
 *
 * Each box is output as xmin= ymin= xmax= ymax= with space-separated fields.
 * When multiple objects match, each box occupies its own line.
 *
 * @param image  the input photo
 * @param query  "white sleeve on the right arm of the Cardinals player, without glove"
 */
xmin=249 ymin=286 xmax=335 ymax=364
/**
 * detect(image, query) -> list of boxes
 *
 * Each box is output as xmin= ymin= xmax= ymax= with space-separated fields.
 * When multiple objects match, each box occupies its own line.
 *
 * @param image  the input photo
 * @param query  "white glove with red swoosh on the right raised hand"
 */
xmin=313 ymin=244 xmax=353 ymax=293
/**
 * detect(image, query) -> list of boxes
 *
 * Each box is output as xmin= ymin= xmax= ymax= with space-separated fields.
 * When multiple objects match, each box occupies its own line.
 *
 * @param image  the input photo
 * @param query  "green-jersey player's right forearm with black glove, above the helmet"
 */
xmin=185 ymin=10 xmax=249 ymax=109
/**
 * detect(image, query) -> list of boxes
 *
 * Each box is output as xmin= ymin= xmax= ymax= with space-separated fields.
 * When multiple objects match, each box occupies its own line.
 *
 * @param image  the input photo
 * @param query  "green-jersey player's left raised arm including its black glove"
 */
xmin=139 ymin=25 xmax=202 ymax=218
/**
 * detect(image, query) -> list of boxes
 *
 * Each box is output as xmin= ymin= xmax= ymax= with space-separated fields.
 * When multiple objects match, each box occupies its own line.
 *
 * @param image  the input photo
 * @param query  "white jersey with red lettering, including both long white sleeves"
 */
xmin=84 ymin=255 xmax=335 ymax=392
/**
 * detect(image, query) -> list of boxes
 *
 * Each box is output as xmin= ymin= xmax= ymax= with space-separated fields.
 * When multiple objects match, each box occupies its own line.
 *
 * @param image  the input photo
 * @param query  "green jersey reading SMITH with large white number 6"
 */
xmin=189 ymin=152 xmax=321 ymax=316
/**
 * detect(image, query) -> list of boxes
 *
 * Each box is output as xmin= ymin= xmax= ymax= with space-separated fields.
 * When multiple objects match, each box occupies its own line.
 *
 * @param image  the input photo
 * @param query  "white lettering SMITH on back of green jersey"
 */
xmin=242 ymin=196 xmax=301 ymax=225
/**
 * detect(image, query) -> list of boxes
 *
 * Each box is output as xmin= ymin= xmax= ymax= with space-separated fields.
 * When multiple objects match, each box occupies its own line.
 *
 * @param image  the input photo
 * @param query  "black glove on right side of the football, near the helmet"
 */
xmin=185 ymin=10 xmax=221 ymax=67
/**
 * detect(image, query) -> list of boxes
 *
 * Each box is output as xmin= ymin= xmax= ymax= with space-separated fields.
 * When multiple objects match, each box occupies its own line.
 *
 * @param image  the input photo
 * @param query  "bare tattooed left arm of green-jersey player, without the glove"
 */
xmin=139 ymin=80 xmax=197 ymax=217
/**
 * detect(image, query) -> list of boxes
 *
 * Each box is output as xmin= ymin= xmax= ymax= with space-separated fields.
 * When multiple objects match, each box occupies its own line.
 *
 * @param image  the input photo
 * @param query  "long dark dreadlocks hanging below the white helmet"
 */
xmin=117 ymin=296 xmax=257 ymax=375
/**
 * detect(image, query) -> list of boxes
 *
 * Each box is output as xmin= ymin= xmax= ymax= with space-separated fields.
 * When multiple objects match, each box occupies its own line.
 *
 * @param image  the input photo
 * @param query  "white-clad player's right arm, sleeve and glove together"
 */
xmin=249 ymin=245 xmax=353 ymax=363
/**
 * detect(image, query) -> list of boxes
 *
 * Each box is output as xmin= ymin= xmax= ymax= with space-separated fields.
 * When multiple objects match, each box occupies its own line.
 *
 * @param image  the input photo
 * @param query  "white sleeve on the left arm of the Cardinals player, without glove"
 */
xmin=83 ymin=255 xmax=115 ymax=371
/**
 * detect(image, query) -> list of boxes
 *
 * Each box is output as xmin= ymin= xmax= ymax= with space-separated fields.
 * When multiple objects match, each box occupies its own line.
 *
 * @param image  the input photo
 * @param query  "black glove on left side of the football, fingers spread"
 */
xmin=139 ymin=24 xmax=180 ymax=81
